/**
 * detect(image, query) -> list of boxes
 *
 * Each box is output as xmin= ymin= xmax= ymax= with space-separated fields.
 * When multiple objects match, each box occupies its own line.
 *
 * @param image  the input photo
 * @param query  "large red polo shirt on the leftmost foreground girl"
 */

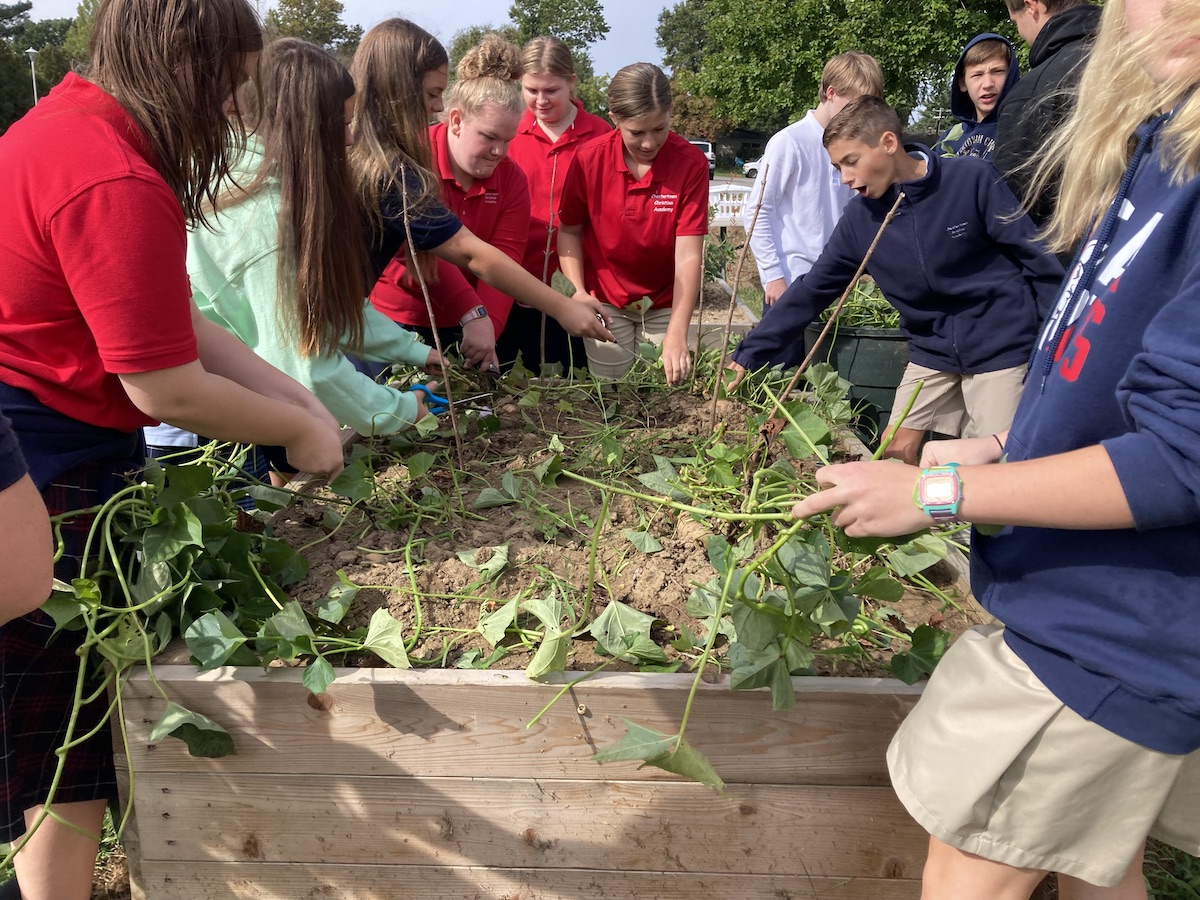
xmin=0 ymin=73 xmax=197 ymax=431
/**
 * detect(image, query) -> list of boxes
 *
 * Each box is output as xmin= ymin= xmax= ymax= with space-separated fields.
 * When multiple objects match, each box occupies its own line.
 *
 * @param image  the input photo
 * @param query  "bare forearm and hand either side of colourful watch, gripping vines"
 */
xmin=792 ymin=437 xmax=1133 ymax=536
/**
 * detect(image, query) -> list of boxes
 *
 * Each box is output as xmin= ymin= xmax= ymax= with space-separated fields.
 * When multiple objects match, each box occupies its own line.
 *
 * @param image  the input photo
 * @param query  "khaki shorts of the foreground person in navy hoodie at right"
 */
xmin=888 ymin=625 xmax=1200 ymax=887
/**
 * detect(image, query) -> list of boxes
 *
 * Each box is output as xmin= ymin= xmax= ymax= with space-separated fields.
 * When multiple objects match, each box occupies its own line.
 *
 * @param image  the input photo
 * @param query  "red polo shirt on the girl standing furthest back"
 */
xmin=509 ymin=100 xmax=612 ymax=281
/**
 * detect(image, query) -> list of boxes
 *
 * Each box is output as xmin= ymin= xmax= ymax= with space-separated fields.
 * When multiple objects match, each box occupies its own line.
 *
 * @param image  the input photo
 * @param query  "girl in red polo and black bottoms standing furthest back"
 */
xmin=497 ymin=37 xmax=612 ymax=372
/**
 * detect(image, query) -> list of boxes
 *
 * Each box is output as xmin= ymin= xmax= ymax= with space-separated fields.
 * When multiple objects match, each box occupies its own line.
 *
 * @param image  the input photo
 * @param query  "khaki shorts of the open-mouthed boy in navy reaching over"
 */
xmin=888 ymin=362 xmax=1025 ymax=438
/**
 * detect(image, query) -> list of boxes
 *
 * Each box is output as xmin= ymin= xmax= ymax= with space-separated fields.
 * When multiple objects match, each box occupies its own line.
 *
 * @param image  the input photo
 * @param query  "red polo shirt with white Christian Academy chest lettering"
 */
xmin=559 ymin=131 xmax=708 ymax=308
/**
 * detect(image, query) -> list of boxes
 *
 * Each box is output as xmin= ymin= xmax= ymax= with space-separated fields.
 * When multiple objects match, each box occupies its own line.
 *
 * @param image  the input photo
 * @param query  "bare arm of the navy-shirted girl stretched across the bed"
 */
xmin=432 ymin=228 xmax=613 ymax=341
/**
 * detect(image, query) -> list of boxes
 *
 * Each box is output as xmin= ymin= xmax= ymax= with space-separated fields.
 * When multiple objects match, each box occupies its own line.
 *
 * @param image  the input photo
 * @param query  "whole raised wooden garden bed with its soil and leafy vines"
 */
xmin=93 ymin=364 xmax=979 ymax=900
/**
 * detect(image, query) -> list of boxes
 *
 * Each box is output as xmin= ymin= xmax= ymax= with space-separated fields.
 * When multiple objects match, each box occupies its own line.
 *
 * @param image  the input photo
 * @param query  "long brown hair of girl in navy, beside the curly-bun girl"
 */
xmin=350 ymin=18 xmax=450 ymax=243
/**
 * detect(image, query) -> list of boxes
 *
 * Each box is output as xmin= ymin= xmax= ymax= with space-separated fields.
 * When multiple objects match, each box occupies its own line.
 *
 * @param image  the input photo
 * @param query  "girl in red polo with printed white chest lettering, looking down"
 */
xmin=558 ymin=62 xmax=708 ymax=384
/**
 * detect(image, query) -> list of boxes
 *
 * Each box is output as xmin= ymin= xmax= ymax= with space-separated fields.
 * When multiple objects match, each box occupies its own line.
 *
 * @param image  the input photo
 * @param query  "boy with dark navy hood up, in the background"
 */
xmin=934 ymin=32 xmax=1020 ymax=160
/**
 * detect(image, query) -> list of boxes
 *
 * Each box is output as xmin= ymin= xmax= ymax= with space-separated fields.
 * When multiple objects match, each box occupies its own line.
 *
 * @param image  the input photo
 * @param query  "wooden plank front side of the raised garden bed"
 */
xmin=125 ymin=665 xmax=926 ymax=900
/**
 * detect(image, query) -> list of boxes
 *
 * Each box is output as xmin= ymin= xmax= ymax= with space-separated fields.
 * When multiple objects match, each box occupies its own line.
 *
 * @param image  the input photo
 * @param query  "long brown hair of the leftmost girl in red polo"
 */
xmin=88 ymin=0 xmax=263 ymax=224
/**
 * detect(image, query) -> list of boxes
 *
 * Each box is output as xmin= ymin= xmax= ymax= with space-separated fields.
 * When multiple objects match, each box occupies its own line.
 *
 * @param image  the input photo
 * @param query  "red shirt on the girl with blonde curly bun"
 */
xmin=371 ymin=122 xmax=529 ymax=336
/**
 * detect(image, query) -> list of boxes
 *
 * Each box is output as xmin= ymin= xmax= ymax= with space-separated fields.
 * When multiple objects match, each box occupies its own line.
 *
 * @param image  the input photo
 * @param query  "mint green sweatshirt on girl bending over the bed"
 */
xmin=187 ymin=138 xmax=430 ymax=434
